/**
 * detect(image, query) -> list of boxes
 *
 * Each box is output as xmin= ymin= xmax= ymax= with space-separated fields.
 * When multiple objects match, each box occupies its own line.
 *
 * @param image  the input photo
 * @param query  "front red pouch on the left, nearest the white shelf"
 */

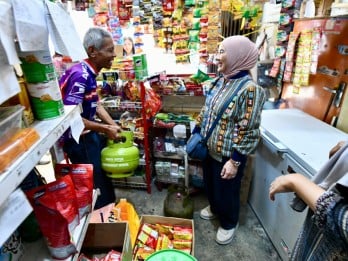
xmin=26 ymin=176 xmax=79 ymax=259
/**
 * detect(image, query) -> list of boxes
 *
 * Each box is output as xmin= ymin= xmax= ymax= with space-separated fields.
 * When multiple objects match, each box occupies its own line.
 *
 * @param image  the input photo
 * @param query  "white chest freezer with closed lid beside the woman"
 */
xmin=249 ymin=109 xmax=348 ymax=260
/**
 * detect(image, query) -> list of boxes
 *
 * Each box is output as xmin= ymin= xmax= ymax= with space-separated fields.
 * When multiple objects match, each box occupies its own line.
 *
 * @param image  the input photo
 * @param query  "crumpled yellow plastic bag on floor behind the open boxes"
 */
xmin=111 ymin=198 xmax=140 ymax=247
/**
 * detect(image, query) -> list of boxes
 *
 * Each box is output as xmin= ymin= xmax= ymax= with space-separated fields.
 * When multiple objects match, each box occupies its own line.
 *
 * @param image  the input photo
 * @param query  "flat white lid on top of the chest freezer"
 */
xmin=261 ymin=109 xmax=348 ymax=175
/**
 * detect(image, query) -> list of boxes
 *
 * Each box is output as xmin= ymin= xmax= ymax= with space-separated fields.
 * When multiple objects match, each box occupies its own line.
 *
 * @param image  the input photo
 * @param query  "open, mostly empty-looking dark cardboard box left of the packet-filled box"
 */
xmin=80 ymin=222 xmax=132 ymax=261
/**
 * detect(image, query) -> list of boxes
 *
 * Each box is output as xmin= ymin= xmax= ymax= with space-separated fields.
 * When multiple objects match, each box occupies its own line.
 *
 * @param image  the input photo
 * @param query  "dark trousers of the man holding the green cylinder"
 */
xmin=63 ymin=132 xmax=116 ymax=209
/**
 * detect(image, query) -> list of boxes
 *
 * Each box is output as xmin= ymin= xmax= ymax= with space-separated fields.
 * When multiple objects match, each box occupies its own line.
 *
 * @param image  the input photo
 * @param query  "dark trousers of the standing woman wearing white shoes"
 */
xmin=203 ymin=153 xmax=247 ymax=229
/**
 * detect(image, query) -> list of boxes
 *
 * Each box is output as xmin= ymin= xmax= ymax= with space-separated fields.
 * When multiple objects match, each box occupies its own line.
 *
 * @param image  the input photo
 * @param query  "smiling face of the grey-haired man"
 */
xmin=94 ymin=37 xmax=116 ymax=70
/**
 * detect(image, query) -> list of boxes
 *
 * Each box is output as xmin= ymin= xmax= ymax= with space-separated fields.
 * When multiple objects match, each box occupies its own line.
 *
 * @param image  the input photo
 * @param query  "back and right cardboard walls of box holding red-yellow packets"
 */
xmin=140 ymin=215 xmax=195 ymax=256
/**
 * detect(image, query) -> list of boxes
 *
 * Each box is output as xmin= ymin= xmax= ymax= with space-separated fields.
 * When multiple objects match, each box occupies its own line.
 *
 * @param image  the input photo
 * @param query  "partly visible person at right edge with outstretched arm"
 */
xmin=269 ymin=141 xmax=348 ymax=261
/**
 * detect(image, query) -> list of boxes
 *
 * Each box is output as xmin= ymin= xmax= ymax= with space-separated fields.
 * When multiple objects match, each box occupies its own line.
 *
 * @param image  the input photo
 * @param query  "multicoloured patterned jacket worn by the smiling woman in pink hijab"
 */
xmin=196 ymin=75 xmax=265 ymax=160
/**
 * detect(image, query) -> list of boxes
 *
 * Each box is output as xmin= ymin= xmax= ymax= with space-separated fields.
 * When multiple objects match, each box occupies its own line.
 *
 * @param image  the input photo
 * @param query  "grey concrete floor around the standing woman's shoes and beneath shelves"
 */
xmin=116 ymin=183 xmax=281 ymax=261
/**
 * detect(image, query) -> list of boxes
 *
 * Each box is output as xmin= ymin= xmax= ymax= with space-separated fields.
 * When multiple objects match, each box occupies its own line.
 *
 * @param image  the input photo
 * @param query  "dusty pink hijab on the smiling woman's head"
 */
xmin=221 ymin=35 xmax=258 ymax=78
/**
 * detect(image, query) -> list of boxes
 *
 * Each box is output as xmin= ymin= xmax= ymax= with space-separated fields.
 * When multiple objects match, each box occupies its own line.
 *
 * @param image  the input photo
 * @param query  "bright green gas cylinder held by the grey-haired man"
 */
xmin=101 ymin=131 xmax=139 ymax=178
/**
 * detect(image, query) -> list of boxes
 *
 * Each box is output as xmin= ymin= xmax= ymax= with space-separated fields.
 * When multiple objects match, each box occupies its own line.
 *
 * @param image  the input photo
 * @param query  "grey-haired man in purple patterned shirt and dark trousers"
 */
xmin=59 ymin=28 xmax=121 ymax=209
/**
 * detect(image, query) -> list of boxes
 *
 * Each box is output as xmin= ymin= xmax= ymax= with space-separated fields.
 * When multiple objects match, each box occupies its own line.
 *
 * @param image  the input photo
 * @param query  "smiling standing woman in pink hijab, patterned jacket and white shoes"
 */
xmin=193 ymin=36 xmax=265 ymax=245
